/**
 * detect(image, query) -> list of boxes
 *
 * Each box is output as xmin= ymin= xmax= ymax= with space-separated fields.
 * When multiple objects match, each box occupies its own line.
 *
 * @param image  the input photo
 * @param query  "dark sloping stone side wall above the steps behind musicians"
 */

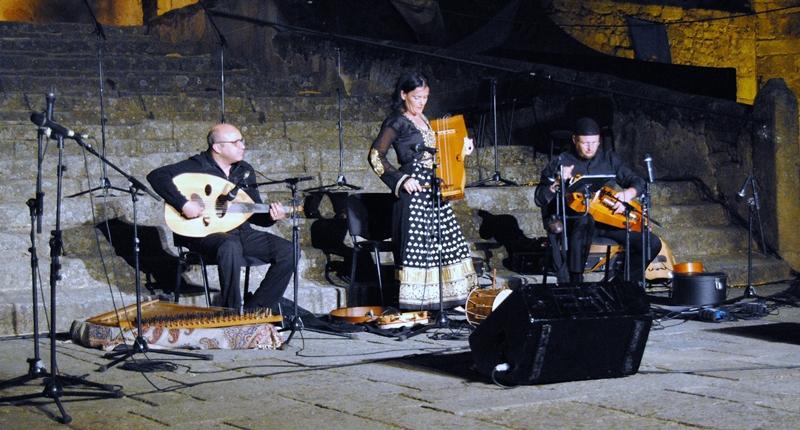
xmin=147 ymin=2 xmax=792 ymax=239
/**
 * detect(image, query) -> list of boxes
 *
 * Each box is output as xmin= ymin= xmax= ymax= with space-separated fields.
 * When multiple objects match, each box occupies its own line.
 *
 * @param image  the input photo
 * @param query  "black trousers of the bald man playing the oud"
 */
xmin=189 ymin=227 xmax=294 ymax=310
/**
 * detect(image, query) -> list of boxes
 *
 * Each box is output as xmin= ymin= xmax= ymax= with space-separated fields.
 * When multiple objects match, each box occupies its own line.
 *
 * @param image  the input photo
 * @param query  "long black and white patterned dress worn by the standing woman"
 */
xmin=369 ymin=113 xmax=477 ymax=309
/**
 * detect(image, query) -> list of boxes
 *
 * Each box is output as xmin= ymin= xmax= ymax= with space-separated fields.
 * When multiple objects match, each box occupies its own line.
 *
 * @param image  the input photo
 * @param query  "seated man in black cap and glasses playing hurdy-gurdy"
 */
xmin=535 ymin=118 xmax=661 ymax=283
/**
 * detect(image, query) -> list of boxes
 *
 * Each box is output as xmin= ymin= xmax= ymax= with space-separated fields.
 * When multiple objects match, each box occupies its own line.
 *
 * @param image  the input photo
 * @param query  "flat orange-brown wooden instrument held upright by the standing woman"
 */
xmin=431 ymin=115 xmax=473 ymax=200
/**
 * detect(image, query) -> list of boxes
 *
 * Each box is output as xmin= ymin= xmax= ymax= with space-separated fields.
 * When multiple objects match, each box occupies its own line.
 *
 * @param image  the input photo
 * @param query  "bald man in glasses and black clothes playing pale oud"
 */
xmin=147 ymin=124 xmax=293 ymax=311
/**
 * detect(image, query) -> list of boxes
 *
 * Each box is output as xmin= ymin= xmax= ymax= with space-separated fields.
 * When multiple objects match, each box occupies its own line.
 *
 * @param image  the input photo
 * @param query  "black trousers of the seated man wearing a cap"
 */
xmin=549 ymin=216 xmax=661 ymax=283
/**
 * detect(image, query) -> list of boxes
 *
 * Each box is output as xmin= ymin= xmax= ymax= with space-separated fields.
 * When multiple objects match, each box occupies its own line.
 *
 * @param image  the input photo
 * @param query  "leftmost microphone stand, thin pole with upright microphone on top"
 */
xmin=0 ymin=93 xmax=56 ymax=396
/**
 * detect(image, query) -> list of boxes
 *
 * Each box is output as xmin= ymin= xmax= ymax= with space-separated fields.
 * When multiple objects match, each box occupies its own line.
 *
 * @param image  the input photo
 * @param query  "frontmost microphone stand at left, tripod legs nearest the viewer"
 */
xmin=0 ymin=123 xmax=124 ymax=424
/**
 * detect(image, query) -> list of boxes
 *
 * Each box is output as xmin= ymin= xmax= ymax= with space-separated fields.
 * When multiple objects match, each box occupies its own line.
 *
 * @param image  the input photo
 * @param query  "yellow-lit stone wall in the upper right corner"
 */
xmin=549 ymin=0 xmax=800 ymax=104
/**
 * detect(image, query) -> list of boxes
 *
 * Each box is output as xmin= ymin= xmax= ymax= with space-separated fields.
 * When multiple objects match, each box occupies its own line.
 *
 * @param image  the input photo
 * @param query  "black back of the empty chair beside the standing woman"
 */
xmin=347 ymin=193 xmax=397 ymax=241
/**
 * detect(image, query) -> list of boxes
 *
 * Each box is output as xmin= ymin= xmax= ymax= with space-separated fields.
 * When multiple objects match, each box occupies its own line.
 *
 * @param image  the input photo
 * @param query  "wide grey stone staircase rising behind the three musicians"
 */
xmin=0 ymin=23 xmax=789 ymax=334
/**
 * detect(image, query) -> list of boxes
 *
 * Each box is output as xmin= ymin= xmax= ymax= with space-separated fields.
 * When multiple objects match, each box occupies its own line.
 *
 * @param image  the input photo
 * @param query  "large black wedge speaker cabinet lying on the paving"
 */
xmin=469 ymin=281 xmax=652 ymax=384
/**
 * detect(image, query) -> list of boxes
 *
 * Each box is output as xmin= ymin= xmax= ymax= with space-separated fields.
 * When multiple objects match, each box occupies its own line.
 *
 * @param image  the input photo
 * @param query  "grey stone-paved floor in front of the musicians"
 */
xmin=0 ymin=285 xmax=800 ymax=430
